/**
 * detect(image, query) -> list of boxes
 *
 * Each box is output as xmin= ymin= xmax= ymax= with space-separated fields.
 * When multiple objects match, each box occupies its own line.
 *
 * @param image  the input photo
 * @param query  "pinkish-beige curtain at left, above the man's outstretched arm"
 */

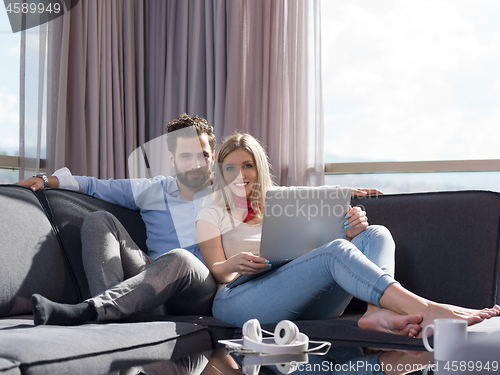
xmin=47 ymin=0 xmax=150 ymax=178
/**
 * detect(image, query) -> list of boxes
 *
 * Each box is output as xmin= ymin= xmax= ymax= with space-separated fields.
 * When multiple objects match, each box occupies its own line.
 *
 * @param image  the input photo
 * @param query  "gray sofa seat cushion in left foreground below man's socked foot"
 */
xmin=0 ymin=319 xmax=212 ymax=375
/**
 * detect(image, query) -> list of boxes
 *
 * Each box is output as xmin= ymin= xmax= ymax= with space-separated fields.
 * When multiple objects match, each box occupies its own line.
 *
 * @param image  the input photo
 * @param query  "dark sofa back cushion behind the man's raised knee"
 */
xmin=43 ymin=189 xmax=147 ymax=299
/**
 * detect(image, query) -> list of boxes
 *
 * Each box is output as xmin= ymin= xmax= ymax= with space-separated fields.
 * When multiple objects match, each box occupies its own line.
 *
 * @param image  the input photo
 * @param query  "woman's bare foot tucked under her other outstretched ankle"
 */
xmin=358 ymin=305 xmax=422 ymax=337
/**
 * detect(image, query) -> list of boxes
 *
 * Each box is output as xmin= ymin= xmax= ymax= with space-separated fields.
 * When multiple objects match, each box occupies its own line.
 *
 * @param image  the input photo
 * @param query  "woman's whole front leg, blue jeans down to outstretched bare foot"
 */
xmin=212 ymin=240 xmax=500 ymax=333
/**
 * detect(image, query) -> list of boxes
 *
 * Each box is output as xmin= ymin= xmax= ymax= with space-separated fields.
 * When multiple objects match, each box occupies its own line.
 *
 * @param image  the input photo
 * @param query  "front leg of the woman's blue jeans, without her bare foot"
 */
xmin=213 ymin=240 xmax=396 ymax=325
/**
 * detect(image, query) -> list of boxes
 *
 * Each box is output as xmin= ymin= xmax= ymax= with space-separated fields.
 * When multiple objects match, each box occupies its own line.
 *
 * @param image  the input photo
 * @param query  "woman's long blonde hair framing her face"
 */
xmin=212 ymin=133 xmax=274 ymax=216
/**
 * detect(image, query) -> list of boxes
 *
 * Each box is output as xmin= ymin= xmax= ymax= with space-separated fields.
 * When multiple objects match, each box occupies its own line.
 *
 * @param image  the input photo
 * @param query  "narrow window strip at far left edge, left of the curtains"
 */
xmin=0 ymin=9 xmax=21 ymax=183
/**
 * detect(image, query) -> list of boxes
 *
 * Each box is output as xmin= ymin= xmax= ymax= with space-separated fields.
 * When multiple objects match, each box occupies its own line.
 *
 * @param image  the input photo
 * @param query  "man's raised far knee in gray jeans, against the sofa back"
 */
xmin=81 ymin=211 xmax=152 ymax=296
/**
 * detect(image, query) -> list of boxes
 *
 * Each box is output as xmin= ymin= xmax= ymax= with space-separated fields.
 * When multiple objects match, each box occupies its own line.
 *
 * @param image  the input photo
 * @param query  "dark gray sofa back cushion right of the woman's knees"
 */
xmin=352 ymin=191 xmax=500 ymax=308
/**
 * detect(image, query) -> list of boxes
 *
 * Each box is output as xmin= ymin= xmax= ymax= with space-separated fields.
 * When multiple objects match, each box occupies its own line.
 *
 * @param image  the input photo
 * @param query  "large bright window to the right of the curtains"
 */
xmin=321 ymin=0 xmax=500 ymax=192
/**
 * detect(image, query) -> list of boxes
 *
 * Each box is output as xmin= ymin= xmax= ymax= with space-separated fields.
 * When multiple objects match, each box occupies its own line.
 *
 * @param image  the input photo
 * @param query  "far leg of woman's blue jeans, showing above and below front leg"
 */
xmin=298 ymin=225 xmax=395 ymax=320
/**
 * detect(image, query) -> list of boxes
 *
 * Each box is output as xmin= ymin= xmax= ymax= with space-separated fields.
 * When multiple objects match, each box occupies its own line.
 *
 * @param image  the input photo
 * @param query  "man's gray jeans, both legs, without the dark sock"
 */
xmin=81 ymin=211 xmax=216 ymax=321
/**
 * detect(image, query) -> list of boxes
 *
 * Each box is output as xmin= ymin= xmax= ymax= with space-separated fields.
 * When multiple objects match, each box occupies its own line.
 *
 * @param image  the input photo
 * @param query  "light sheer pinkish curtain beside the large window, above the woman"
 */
xmin=223 ymin=0 xmax=323 ymax=185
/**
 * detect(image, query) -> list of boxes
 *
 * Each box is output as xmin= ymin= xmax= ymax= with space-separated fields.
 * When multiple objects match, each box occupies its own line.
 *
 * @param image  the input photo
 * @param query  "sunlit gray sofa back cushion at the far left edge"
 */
xmin=0 ymin=185 xmax=79 ymax=317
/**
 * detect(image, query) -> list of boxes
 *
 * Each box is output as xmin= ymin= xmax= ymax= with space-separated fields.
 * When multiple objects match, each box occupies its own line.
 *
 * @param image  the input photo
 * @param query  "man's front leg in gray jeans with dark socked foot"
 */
xmin=32 ymin=249 xmax=216 ymax=325
